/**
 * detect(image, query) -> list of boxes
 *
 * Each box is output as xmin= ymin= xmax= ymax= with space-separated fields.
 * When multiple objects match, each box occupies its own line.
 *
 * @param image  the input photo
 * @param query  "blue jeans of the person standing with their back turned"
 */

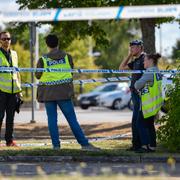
xmin=45 ymin=99 xmax=89 ymax=147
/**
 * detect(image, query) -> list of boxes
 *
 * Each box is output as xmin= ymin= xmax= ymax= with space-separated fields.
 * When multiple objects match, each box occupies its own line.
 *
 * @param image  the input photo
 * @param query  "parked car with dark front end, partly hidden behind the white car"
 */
xmin=77 ymin=82 xmax=128 ymax=109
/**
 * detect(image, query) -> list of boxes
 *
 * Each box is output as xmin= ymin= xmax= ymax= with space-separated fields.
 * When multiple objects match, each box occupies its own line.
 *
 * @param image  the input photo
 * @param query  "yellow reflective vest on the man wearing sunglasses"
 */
xmin=0 ymin=50 xmax=21 ymax=94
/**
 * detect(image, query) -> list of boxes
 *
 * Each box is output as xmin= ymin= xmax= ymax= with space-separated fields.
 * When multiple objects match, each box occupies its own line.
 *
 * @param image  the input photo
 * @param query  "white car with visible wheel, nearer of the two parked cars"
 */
xmin=96 ymin=83 xmax=131 ymax=109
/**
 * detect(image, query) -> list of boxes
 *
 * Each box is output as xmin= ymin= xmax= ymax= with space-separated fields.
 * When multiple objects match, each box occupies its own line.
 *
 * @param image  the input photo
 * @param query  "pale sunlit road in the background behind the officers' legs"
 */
xmin=15 ymin=108 xmax=132 ymax=124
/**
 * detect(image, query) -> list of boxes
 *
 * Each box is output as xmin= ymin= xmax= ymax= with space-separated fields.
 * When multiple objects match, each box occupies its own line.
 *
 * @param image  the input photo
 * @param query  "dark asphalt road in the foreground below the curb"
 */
xmin=0 ymin=162 xmax=180 ymax=177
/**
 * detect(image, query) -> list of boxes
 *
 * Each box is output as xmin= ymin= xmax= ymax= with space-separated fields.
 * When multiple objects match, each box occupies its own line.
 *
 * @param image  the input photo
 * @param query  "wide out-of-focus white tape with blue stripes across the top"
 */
xmin=0 ymin=4 xmax=180 ymax=22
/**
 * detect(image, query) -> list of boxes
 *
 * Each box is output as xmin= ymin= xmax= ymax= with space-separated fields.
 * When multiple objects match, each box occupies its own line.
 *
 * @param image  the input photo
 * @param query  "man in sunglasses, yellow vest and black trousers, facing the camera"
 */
xmin=0 ymin=32 xmax=21 ymax=146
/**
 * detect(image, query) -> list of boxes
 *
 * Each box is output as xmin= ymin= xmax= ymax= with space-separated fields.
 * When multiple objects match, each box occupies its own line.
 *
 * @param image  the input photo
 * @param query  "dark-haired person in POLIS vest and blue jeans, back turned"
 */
xmin=35 ymin=34 xmax=99 ymax=151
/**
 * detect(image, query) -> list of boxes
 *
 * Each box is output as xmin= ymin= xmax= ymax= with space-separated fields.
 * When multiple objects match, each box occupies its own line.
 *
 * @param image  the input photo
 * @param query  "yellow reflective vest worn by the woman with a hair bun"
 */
xmin=141 ymin=73 xmax=163 ymax=118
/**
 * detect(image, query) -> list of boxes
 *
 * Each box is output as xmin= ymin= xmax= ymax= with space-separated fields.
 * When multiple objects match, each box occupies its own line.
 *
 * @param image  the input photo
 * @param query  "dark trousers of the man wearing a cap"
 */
xmin=131 ymin=91 xmax=141 ymax=149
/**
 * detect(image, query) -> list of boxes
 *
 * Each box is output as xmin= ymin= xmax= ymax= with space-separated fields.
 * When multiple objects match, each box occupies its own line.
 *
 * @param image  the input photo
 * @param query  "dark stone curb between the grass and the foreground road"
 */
xmin=0 ymin=156 xmax=180 ymax=163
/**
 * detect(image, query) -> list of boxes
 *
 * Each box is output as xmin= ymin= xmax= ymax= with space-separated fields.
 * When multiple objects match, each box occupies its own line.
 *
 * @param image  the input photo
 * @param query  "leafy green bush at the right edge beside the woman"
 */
xmin=157 ymin=69 xmax=180 ymax=151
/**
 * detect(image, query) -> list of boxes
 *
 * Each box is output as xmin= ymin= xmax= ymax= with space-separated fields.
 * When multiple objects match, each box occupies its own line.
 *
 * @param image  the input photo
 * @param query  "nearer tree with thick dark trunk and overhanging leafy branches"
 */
xmin=16 ymin=0 xmax=179 ymax=53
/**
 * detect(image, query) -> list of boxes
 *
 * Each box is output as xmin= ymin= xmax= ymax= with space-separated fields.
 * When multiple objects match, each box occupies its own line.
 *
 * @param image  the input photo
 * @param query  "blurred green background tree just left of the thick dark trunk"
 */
xmin=95 ymin=20 xmax=140 ymax=77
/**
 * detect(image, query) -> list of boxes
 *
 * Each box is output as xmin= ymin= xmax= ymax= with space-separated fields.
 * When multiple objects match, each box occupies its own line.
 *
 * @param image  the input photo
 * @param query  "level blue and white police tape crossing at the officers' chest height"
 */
xmin=0 ymin=66 xmax=180 ymax=74
